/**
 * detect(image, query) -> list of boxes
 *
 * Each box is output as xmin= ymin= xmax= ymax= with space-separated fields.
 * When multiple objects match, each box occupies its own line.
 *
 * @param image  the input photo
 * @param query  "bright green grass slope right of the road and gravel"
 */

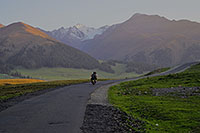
xmin=109 ymin=64 xmax=200 ymax=133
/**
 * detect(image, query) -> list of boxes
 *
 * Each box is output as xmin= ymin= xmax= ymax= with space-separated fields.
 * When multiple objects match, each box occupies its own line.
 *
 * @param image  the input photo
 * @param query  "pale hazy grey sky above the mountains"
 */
xmin=0 ymin=0 xmax=200 ymax=30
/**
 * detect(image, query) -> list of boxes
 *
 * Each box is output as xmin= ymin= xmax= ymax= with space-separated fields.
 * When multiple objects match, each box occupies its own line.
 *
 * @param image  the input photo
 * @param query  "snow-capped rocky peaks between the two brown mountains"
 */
xmin=40 ymin=24 xmax=109 ymax=49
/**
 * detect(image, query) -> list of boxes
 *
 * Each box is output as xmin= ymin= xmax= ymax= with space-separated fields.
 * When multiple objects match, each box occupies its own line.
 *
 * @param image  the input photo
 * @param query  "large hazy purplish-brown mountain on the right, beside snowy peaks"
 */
xmin=82 ymin=14 xmax=200 ymax=67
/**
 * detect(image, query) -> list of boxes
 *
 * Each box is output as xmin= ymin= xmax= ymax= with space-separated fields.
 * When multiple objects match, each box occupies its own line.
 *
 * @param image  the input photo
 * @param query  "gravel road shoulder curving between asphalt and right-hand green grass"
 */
xmin=81 ymin=82 xmax=142 ymax=133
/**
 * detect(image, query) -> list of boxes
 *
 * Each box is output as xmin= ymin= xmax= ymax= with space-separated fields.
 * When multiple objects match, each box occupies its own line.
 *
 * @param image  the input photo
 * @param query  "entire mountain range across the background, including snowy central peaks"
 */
xmin=0 ymin=13 xmax=200 ymax=72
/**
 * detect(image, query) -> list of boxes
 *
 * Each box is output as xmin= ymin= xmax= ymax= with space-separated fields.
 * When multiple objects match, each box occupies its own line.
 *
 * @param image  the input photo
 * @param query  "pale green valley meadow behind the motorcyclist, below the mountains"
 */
xmin=17 ymin=64 xmax=138 ymax=80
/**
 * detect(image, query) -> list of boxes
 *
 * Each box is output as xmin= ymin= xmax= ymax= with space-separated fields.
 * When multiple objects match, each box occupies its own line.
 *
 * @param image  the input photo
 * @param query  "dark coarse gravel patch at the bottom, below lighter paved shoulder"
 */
xmin=81 ymin=104 xmax=144 ymax=133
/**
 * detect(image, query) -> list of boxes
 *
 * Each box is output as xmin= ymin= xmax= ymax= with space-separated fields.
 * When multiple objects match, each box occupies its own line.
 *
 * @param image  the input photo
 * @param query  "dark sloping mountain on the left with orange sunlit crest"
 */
xmin=0 ymin=22 xmax=109 ymax=70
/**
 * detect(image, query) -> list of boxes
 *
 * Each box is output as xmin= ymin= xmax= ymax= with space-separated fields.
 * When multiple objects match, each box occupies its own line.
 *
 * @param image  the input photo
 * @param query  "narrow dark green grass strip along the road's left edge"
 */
xmin=0 ymin=80 xmax=89 ymax=101
